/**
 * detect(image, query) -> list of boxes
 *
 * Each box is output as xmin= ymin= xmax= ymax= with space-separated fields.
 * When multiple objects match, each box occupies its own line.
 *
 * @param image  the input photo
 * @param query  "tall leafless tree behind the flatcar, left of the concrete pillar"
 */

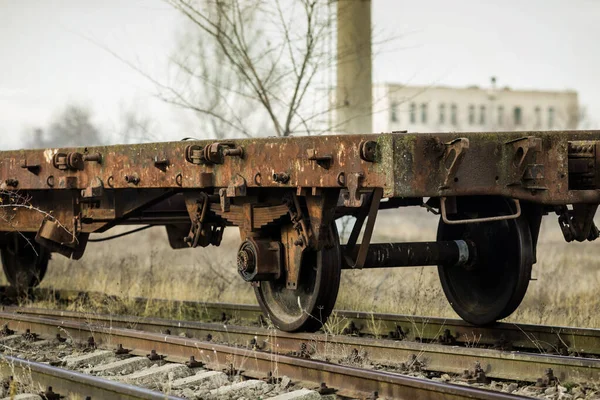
xmin=166 ymin=0 xmax=333 ymax=137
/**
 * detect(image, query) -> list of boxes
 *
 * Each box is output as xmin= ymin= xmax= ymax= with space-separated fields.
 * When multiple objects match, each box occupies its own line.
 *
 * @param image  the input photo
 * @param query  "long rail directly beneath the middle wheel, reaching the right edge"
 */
xmin=7 ymin=307 xmax=600 ymax=382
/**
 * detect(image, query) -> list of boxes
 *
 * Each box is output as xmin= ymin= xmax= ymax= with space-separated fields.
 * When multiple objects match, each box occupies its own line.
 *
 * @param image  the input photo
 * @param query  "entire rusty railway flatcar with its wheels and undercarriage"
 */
xmin=0 ymin=131 xmax=600 ymax=331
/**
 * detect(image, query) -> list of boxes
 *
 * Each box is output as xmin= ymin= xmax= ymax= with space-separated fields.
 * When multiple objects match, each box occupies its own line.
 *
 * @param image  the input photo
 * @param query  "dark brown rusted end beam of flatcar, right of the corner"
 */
xmin=393 ymin=131 xmax=600 ymax=204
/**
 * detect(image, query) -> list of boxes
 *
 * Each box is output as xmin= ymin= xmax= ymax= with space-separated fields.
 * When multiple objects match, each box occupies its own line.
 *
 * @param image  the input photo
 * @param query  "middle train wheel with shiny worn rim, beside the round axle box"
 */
xmin=254 ymin=225 xmax=341 ymax=332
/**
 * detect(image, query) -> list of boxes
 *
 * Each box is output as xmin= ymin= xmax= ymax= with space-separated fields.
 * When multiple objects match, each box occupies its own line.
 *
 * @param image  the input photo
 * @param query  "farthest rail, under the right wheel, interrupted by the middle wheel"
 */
xmin=21 ymin=289 xmax=600 ymax=356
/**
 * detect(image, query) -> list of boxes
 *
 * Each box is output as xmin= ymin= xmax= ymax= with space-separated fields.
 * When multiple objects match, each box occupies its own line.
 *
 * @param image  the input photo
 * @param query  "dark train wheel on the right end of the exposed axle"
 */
xmin=437 ymin=197 xmax=533 ymax=325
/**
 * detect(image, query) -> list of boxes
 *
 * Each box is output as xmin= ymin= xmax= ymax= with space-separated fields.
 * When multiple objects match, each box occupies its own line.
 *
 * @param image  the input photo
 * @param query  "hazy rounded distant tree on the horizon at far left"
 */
xmin=24 ymin=105 xmax=106 ymax=148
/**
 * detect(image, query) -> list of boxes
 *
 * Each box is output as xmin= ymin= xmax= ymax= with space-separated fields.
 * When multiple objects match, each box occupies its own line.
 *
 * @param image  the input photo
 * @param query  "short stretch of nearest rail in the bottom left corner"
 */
xmin=0 ymin=355 xmax=181 ymax=400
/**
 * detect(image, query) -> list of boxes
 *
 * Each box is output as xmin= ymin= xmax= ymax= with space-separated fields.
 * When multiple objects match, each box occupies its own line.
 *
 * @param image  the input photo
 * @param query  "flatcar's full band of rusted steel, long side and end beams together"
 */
xmin=0 ymin=131 xmax=600 ymax=203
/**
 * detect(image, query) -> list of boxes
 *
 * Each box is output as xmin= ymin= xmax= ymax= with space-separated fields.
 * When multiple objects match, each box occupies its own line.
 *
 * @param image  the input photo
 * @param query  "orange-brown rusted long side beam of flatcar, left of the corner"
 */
xmin=0 ymin=135 xmax=393 ymax=193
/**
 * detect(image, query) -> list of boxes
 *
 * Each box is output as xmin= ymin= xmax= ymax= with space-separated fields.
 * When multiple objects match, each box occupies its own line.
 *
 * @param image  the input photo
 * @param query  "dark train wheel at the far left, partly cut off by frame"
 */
xmin=0 ymin=232 xmax=50 ymax=293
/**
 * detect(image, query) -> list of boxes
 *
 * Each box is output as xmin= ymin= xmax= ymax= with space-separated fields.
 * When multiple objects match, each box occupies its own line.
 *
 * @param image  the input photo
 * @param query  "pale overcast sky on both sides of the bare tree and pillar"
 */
xmin=0 ymin=0 xmax=600 ymax=148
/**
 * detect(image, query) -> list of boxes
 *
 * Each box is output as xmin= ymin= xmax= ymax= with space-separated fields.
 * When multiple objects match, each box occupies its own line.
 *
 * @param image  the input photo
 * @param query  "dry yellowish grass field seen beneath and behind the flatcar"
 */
xmin=4 ymin=208 xmax=600 ymax=328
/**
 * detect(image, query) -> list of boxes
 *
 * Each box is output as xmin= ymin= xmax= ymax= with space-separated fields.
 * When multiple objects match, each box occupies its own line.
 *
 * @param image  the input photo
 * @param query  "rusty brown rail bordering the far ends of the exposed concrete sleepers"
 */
xmin=0 ymin=312 xmax=522 ymax=400
